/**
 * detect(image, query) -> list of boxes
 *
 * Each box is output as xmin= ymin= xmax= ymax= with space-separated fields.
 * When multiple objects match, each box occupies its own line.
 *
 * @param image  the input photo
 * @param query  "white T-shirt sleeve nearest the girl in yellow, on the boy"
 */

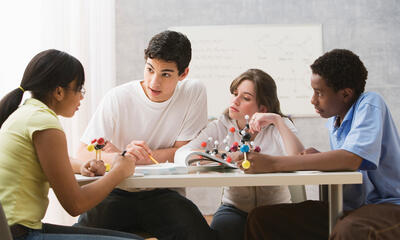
xmin=80 ymin=91 xmax=119 ymax=144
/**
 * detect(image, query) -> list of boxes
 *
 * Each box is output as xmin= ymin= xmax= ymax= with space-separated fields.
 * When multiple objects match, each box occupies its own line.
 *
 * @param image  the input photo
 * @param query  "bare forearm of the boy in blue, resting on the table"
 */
xmin=272 ymin=150 xmax=362 ymax=172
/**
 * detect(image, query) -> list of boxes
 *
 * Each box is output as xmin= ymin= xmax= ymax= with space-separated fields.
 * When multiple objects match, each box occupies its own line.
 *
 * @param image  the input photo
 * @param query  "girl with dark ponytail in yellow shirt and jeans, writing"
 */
xmin=0 ymin=49 xmax=141 ymax=240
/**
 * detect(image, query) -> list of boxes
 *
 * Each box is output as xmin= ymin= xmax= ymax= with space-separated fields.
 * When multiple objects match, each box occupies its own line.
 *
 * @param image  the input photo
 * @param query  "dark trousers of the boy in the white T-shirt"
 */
xmin=76 ymin=189 xmax=217 ymax=240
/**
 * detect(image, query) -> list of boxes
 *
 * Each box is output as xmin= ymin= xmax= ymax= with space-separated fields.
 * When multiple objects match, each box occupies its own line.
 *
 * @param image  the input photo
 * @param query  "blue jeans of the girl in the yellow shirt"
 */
xmin=14 ymin=223 xmax=143 ymax=240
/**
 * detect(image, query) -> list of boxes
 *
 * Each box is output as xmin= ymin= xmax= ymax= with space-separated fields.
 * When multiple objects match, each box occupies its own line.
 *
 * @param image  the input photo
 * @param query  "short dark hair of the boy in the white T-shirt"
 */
xmin=144 ymin=30 xmax=192 ymax=75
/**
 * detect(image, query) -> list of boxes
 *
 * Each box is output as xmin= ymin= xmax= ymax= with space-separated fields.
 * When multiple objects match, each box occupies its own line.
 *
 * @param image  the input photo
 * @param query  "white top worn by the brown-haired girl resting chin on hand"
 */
xmin=175 ymin=115 xmax=297 ymax=212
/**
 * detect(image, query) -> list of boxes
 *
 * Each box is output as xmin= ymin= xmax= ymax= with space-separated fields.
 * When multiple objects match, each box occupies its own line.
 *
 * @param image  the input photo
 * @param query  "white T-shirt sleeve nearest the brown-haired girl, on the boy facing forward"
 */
xmin=176 ymin=80 xmax=207 ymax=141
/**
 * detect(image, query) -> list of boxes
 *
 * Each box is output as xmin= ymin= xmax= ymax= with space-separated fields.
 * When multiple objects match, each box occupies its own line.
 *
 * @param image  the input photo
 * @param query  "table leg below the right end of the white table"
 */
xmin=328 ymin=184 xmax=343 ymax=234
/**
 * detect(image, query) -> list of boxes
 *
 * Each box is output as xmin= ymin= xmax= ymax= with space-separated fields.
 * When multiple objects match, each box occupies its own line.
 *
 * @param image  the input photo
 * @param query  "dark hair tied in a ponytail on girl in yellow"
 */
xmin=0 ymin=49 xmax=85 ymax=128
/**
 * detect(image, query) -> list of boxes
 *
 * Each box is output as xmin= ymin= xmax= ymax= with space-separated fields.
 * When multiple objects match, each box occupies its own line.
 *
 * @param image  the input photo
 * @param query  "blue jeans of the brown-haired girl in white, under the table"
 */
xmin=211 ymin=204 xmax=247 ymax=240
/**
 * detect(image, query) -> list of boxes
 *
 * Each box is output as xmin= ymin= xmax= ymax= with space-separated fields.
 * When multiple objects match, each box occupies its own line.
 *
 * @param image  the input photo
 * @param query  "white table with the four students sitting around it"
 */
xmin=76 ymin=170 xmax=362 ymax=232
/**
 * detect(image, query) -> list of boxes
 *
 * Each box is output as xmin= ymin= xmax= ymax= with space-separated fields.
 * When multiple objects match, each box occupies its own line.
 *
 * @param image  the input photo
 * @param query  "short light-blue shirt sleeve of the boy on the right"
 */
xmin=340 ymin=103 xmax=385 ymax=170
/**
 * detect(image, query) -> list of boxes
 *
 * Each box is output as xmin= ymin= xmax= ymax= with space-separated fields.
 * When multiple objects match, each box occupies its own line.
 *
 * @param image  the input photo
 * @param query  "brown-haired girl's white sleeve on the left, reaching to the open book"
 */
xmin=174 ymin=120 xmax=218 ymax=166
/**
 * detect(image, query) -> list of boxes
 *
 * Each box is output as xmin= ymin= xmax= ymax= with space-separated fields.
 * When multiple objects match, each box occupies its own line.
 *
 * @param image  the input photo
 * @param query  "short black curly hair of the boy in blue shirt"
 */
xmin=311 ymin=49 xmax=368 ymax=97
